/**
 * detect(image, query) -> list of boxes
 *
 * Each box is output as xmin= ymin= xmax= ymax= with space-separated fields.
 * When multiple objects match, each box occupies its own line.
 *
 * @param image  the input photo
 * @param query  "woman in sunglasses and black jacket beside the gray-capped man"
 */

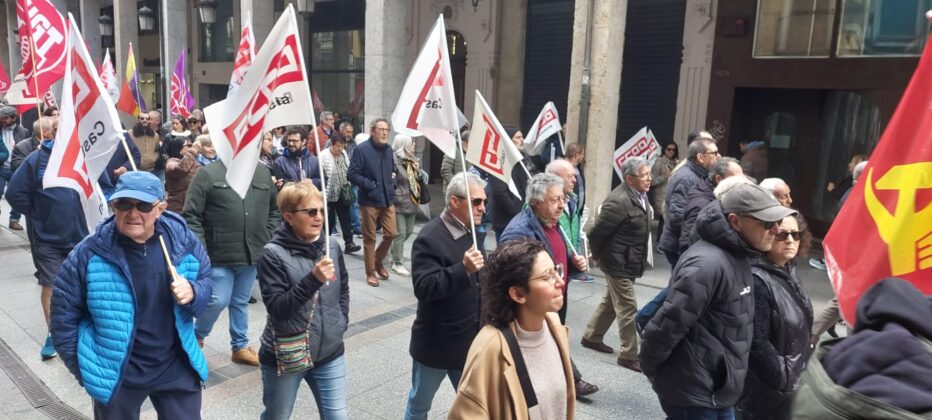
xmin=738 ymin=215 xmax=812 ymax=420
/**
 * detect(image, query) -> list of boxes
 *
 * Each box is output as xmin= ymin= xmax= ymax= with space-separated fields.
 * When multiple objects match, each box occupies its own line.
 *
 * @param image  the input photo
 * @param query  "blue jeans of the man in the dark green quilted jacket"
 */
xmin=195 ymin=265 xmax=256 ymax=351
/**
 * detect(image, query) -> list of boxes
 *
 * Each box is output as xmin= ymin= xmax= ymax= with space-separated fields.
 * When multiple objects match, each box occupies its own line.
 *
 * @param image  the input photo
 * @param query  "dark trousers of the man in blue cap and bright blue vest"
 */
xmin=94 ymin=372 xmax=201 ymax=420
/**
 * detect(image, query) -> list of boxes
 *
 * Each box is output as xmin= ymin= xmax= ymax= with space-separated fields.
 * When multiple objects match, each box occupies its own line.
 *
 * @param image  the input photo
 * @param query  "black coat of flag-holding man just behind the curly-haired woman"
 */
xmin=410 ymin=212 xmax=479 ymax=370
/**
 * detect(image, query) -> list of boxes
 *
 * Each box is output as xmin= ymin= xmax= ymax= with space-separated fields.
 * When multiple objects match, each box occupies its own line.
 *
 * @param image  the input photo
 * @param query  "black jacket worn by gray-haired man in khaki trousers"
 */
xmin=589 ymin=184 xmax=654 ymax=279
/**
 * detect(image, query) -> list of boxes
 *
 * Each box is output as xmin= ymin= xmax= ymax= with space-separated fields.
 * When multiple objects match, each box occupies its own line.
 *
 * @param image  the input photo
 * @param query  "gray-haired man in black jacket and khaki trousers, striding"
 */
xmin=582 ymin=157 xmax=654 ymax=372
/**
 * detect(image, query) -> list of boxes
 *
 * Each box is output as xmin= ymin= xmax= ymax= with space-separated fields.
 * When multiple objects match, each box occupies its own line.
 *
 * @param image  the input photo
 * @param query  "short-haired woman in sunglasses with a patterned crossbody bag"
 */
xmin=258 ymin=180 xmax=349 ymax=419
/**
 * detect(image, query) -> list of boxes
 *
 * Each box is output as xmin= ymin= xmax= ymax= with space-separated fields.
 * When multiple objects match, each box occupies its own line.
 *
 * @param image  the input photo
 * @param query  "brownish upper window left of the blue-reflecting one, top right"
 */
xmin=754 ymin=0 xmax=835 ymax=57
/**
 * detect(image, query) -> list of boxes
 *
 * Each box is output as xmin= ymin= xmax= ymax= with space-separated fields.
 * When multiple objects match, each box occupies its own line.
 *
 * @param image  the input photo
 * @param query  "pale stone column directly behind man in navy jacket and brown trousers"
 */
xmin=363 ymin=0 xmax=408 ymax=130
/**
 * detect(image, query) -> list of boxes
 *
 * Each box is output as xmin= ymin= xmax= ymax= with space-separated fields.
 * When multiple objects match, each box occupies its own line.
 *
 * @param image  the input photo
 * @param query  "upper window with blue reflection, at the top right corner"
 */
xmin=838 ymin=0 xmax=932 ymax=56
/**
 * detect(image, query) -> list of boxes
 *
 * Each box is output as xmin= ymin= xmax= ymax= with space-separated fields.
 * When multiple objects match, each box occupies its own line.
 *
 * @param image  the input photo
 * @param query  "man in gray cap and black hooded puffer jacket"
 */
xmin=639 ymin=184 xmax=796 ymax=419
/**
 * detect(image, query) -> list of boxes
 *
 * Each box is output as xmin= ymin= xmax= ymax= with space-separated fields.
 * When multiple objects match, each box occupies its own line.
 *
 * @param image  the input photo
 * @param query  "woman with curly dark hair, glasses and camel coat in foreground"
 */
xmin=449 ymin=239 xmax=575 ymax=419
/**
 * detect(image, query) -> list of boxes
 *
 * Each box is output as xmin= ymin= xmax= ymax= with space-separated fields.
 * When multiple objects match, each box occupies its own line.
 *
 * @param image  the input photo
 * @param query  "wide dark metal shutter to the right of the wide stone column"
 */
xmin=615 ymin=0 xmax=686 ymax=148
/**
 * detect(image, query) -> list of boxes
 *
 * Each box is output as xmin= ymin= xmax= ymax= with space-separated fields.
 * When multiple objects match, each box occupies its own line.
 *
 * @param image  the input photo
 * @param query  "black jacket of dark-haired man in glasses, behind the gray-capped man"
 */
xmin=659 ymin=162 xmax=709 ymax=254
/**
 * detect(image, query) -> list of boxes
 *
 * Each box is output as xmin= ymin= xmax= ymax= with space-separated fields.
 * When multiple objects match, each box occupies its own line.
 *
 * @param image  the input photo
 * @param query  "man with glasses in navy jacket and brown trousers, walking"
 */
xmin=346 ymin=118 xmax=398 ymax=287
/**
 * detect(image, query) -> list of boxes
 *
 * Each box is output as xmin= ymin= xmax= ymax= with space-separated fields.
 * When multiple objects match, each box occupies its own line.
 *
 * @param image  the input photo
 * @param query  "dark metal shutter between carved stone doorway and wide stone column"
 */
xmin=521 ymin=0 xmax=574 ymax=133
